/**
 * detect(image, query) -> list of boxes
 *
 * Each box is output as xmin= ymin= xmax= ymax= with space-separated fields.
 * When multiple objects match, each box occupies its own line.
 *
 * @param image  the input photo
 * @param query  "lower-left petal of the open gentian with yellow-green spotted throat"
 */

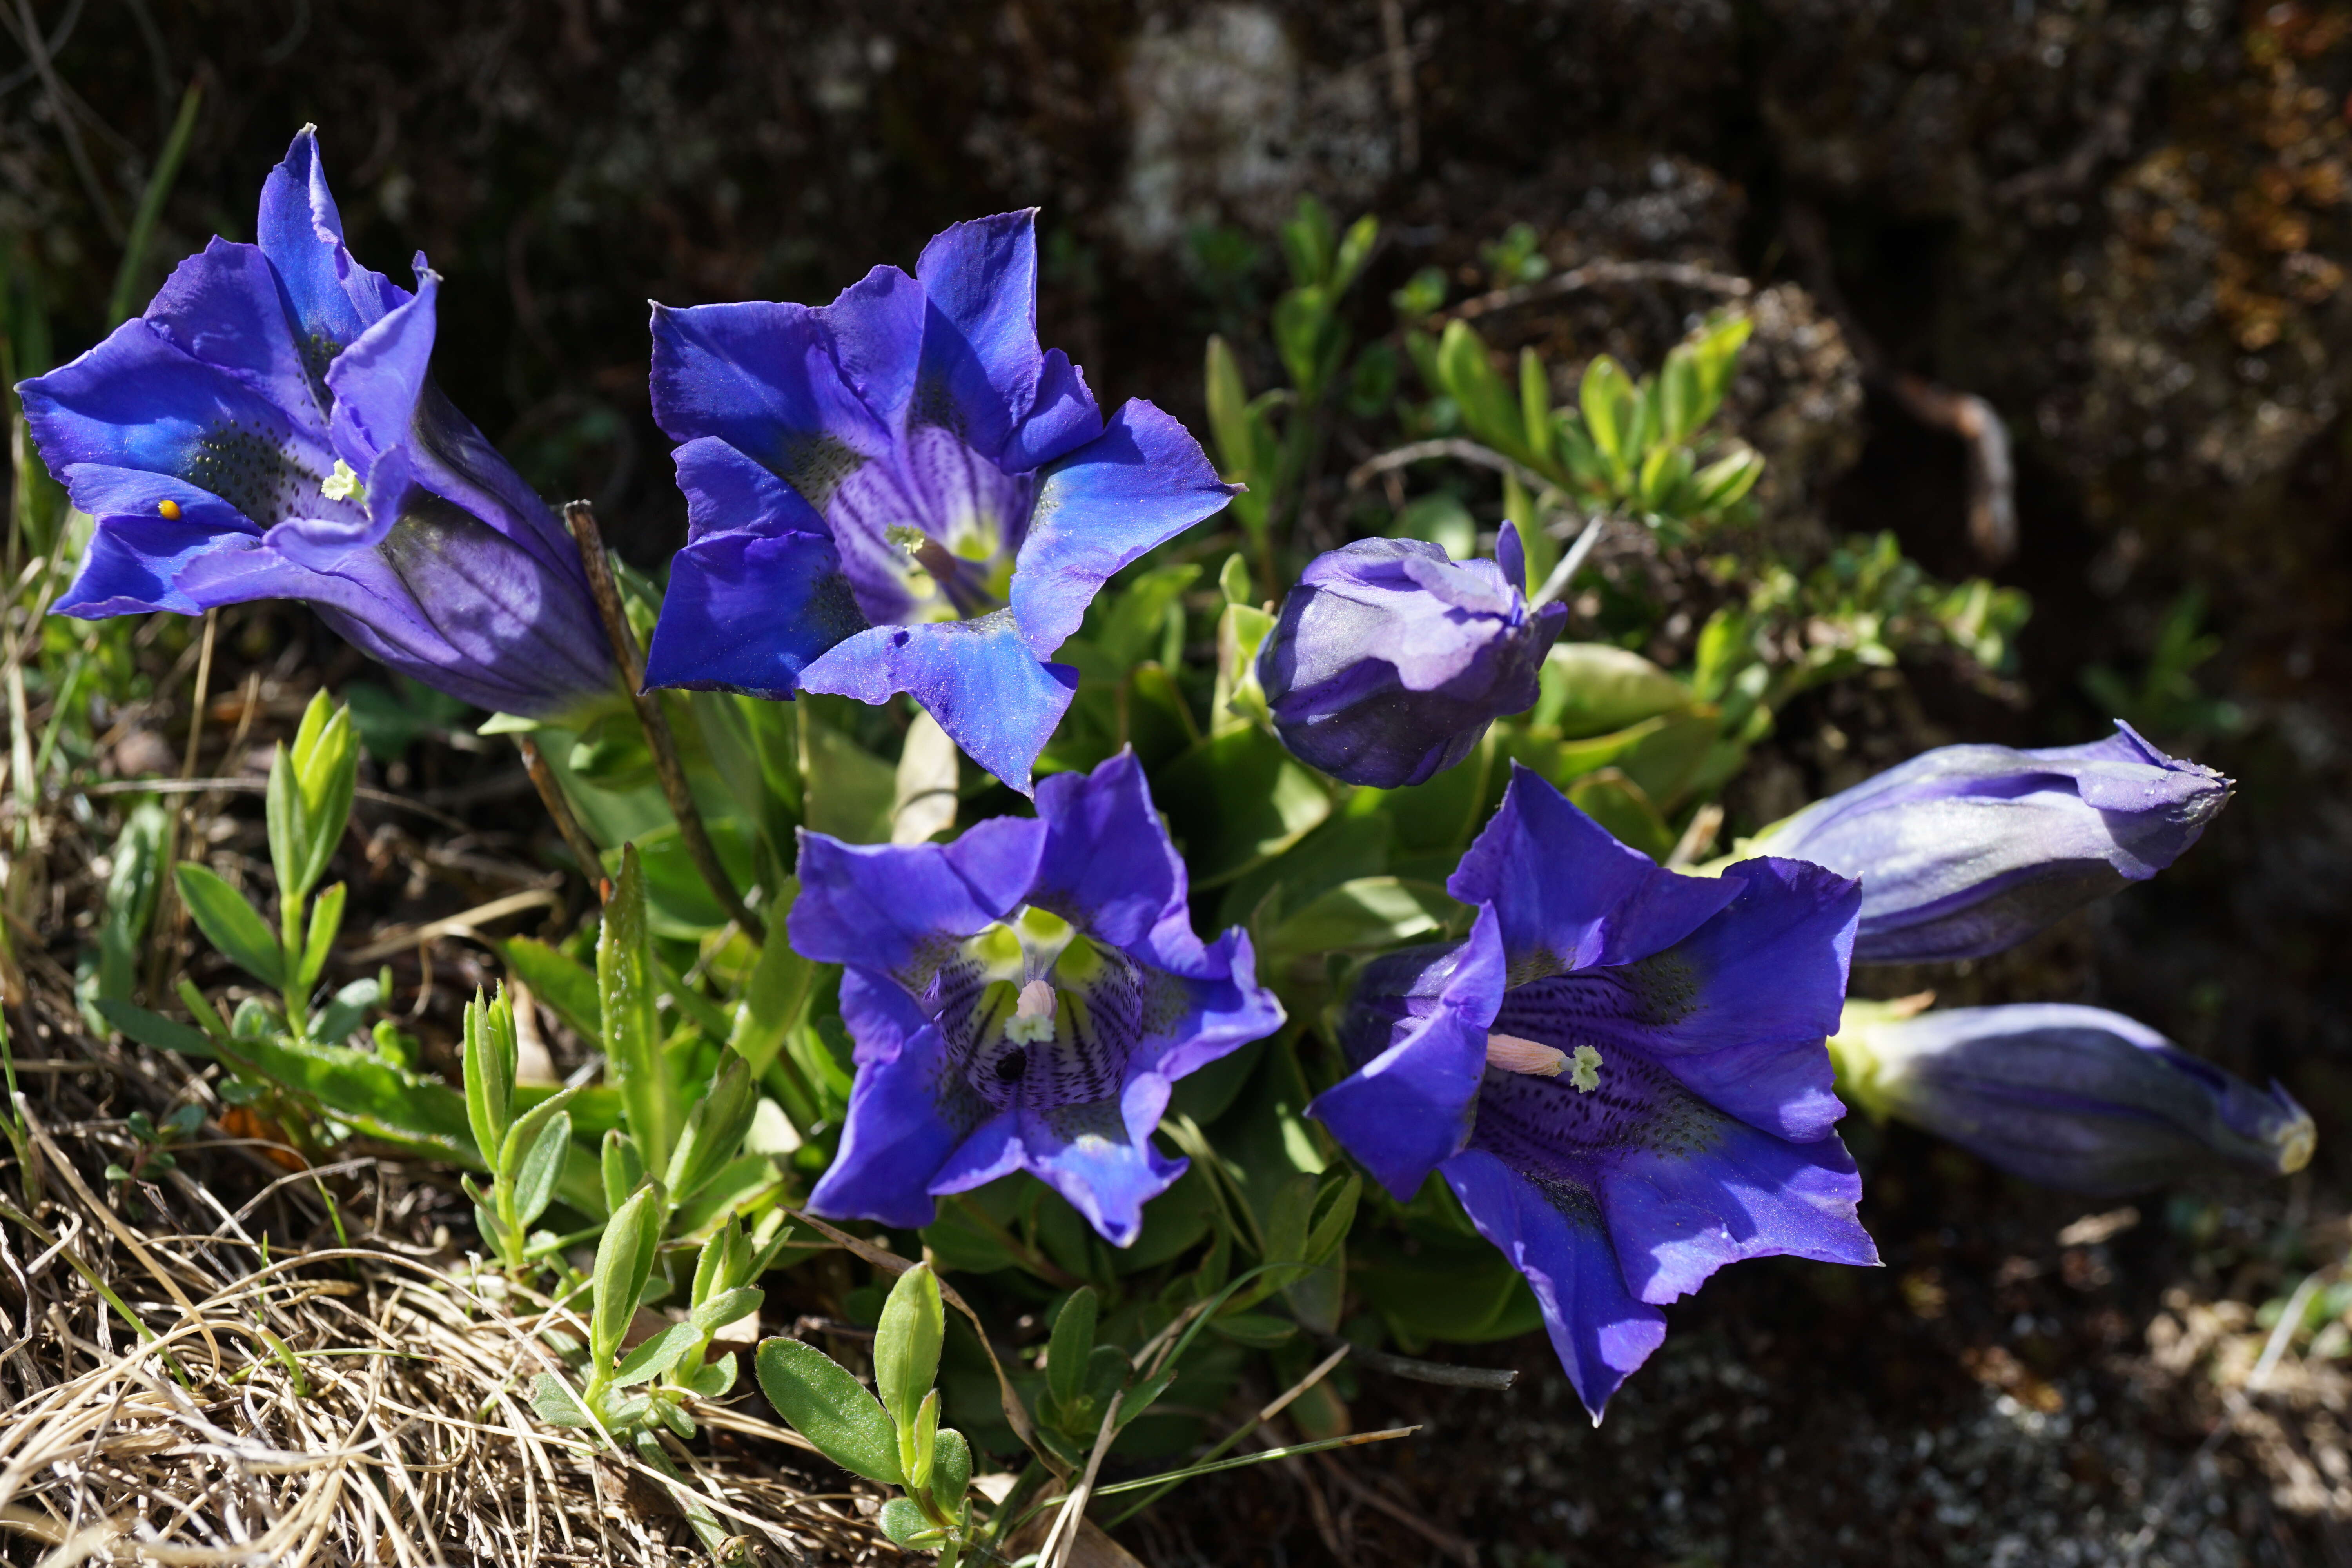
xmin=809 ymin=969 xmax=988 ymax=1229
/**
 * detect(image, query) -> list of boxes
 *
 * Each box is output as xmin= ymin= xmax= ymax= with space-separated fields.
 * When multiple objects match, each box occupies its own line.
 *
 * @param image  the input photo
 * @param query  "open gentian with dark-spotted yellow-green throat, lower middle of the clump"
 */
xmin=790 ymin=752 xmax=1282 ymax=1246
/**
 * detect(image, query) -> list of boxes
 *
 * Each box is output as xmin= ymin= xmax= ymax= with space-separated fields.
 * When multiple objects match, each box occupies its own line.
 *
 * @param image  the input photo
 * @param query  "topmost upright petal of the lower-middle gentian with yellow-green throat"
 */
xmin=1030 ymin=748 xmax=1200 ymax=945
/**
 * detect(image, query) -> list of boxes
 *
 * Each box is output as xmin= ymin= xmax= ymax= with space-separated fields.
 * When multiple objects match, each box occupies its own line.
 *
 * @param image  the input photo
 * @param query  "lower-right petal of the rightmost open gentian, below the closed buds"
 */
xmin=1595 ymin=1117 xmax=1879 ymax=1302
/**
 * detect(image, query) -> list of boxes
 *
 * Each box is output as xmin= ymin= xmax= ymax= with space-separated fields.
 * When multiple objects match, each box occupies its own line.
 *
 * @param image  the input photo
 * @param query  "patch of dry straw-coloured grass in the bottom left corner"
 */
xmin=0 ymin=978 xmax=898 ymax=1568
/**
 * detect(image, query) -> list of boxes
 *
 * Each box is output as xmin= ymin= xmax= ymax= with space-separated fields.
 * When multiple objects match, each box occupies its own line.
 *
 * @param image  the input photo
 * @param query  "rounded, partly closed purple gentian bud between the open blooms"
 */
xmin=1258 ymin=522 xmax=1569 ymax=790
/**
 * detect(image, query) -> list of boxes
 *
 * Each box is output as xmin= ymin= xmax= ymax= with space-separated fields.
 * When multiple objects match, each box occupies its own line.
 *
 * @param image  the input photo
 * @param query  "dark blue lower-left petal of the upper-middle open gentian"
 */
xmin=644 ymin=531 xmax=866 ymax=701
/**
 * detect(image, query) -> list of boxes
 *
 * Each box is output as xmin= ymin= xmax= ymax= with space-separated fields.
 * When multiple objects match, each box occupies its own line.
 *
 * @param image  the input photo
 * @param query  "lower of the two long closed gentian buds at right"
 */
xmin=1830 ymin=1002 xmax=2317 ymax=1196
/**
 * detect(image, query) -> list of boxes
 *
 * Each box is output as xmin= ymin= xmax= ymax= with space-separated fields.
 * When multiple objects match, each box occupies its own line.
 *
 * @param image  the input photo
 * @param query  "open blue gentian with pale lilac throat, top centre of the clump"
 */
xmin=644 ymin=212 xmax=1235 ymax=792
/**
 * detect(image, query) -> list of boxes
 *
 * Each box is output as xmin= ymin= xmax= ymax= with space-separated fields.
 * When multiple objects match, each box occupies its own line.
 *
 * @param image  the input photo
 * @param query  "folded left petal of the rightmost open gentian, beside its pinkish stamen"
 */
xmin=1308 ymin=907 xmax=1503 ymax=1201
